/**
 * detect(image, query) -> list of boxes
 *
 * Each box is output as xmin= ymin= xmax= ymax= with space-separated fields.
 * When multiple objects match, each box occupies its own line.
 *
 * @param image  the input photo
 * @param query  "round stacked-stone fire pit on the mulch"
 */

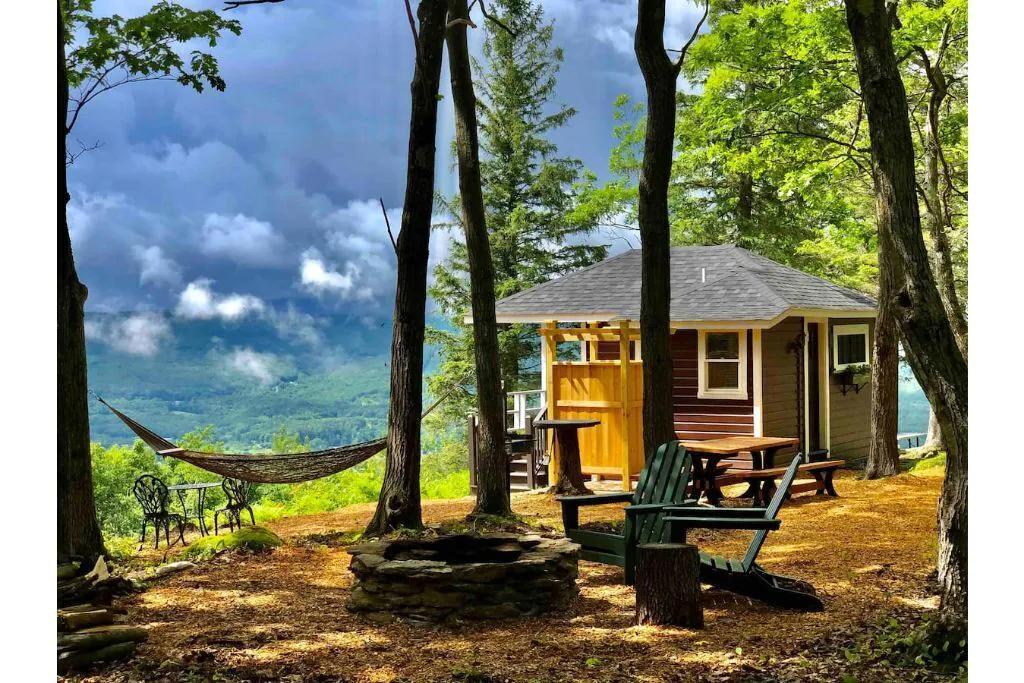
xmin=345 ymin=533 xmax=580 ymax=624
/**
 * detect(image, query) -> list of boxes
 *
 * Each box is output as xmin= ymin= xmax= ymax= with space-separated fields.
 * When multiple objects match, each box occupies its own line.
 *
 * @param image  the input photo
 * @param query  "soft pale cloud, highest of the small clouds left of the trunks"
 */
xmin=199 ymin=213 xmax=288 ymax=266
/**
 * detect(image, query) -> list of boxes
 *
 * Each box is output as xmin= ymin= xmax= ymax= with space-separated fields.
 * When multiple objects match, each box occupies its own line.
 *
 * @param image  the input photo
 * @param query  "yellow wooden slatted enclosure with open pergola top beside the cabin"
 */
xmin=540 ymin=321 xmax=644 ymax=490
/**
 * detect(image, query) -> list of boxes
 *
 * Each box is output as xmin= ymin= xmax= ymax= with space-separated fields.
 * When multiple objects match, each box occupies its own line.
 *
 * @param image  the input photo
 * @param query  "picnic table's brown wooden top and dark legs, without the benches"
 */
xmin=680 ymin=436 xmax=800 ymax=506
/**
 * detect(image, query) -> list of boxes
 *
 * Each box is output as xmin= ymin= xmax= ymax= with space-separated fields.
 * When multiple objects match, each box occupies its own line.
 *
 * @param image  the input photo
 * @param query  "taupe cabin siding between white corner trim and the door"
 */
xmin=761 ymin=316 xmax=804 ymax=444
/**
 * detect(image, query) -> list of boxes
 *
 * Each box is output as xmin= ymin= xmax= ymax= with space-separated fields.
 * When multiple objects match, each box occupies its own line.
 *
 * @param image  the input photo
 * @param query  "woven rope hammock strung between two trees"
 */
xmin=96 ymin=396 xmax=385 ymax=483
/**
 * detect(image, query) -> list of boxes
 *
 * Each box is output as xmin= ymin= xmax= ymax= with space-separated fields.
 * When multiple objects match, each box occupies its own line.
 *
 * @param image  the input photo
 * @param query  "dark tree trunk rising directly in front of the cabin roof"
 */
xmin=633 ymin=0 xmax=679 ymax=458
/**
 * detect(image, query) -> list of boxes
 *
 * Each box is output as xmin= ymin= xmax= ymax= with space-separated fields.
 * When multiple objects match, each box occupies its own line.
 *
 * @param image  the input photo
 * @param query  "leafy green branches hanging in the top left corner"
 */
xmin=61 ymin=0 xmax=242 ymax=132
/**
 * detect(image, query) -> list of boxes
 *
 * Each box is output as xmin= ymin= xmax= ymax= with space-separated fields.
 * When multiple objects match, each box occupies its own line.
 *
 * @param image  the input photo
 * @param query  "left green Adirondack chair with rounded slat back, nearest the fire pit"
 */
xmin=556 ymin=441 xmax=696 ymax=586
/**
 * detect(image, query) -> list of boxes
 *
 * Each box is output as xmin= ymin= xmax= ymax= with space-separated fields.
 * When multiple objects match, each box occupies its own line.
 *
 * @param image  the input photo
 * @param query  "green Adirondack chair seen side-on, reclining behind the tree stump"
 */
xmin=663 ymin=454 xmax=824 ymax=611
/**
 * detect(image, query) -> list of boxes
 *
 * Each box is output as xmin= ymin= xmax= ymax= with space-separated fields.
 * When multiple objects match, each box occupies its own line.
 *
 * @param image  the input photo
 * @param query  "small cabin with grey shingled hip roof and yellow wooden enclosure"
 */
xmin=477 ymin=245 xmax=876 ymax=489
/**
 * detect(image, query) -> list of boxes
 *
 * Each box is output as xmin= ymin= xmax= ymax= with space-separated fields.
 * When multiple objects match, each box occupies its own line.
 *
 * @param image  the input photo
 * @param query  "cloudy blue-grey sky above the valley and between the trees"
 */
xmin=69 ymin=0 xmax=697 ymax=333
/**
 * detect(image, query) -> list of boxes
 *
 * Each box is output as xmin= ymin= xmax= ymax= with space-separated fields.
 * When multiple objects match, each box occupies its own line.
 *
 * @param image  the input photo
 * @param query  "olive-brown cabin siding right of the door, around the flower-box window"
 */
xmin=828 ymin=318 xmax=874 ymax=461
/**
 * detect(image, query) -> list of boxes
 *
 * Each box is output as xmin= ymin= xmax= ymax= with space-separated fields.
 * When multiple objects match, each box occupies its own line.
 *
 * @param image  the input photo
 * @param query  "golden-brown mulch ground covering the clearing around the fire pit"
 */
xmin=64 ymin=470 xmax=942 ymax=682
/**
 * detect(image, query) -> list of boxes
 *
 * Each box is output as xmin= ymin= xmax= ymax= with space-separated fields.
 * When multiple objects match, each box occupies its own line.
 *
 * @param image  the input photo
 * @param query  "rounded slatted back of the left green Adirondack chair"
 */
xmin=625 ymin=441 xmax=691 ymax=543
